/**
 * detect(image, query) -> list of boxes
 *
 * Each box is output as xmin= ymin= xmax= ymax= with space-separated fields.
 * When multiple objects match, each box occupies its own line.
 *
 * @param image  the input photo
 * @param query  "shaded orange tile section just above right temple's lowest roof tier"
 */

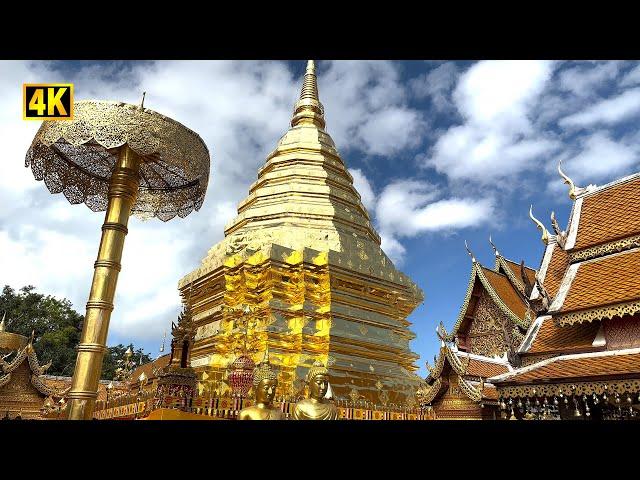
xmin=527 ymin=318 xmax=600 ymax=354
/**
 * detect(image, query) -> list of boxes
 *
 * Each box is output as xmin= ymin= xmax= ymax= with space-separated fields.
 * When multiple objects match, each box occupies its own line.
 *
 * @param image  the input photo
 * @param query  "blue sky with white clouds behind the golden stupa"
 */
xmin=0 ymin=61 xmax=640 ymax=375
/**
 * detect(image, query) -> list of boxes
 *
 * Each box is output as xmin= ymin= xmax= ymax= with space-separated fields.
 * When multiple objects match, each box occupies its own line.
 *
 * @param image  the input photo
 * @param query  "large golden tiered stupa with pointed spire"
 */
xmin=179 ymin=61 xmax=423 ymax=404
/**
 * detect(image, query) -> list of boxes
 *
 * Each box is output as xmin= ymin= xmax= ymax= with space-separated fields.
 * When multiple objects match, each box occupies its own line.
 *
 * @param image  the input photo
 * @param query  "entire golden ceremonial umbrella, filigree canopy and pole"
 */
xmin=25 ymin=97 xmax=209 ymax=419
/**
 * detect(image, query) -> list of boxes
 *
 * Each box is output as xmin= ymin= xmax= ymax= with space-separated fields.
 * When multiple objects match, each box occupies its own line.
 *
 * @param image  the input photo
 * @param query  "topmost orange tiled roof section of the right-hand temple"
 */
xmin=574 ymin=178 xmax=640 ymax=250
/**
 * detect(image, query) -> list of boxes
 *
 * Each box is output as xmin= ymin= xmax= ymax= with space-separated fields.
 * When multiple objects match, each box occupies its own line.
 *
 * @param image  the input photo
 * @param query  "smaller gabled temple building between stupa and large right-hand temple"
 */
xmin=419 ymin=243 xmax=536 ymax=420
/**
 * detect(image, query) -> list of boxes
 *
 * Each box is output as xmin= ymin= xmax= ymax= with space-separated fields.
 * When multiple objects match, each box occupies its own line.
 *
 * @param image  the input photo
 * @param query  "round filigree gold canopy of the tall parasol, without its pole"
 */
xmin=25 ymin=100 xmax=209 ymax=221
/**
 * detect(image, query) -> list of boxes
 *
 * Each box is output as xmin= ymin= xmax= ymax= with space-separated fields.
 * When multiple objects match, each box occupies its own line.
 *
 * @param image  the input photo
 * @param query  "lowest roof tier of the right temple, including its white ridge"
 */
xmin=489 ymin=348 xmax=640 ymax=385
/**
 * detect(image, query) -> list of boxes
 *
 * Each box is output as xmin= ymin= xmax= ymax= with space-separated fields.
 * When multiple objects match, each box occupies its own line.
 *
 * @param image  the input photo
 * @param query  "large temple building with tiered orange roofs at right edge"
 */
xmin=490 ymin=168 xmax=640 ymax=419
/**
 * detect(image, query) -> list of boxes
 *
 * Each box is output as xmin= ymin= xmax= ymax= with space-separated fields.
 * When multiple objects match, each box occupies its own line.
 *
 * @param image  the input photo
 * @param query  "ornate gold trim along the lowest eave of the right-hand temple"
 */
xmin=497 ymin=379 xmax=640 ymax=398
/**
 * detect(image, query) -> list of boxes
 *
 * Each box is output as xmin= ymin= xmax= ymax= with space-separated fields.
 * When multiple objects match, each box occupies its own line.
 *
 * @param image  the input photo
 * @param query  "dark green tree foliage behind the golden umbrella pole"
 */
xmin=0 ymin=285 xmax=151 ymax=380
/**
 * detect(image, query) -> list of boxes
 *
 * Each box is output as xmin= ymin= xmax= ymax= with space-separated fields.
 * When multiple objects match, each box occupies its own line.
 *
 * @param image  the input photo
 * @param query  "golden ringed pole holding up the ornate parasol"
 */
xmin=68 ymin=145 xmax=141 ymax=420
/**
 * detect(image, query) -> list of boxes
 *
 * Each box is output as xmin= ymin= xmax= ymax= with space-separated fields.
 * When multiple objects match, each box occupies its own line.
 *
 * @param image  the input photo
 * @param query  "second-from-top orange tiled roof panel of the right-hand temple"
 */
xmin=561 ymin=249 xmax=640 ymax=313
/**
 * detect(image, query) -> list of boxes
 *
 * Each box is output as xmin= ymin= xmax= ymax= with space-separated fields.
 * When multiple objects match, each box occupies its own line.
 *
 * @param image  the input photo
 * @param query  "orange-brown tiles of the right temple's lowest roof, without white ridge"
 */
xmin=504 ymin=353 xmax=640 ymax=383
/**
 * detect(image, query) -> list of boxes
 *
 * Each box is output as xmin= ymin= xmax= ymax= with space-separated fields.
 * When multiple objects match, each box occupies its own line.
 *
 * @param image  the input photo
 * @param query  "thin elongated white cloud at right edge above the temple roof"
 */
xmin=558 ymin=88 xmax=640 ymax=128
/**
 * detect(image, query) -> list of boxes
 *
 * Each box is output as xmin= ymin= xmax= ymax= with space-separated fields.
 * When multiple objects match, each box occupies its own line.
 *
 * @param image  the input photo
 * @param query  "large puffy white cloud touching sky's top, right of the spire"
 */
xmin=425 ymin=61 xmax=557 ymax=184
